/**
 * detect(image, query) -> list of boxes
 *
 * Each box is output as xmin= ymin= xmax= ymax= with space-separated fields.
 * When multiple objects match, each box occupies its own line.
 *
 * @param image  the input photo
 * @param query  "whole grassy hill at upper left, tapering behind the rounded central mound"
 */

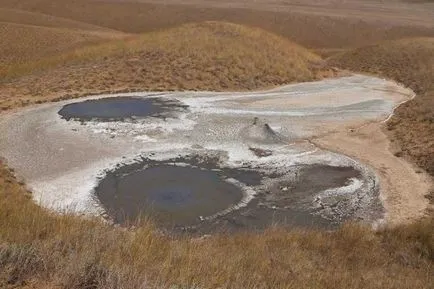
xmin=0 ymin=8 xmax=125 ymax=80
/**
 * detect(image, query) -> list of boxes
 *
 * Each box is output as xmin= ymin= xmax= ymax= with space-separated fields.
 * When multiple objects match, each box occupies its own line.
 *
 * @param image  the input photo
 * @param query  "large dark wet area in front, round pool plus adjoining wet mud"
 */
xmin=95 ymin=157 xmax=380 ymax=234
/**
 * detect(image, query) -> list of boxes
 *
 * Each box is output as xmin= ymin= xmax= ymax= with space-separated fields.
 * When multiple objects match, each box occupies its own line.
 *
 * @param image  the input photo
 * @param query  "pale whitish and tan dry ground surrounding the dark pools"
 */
xmin=0 ymin=75 xmax=430 ymax=224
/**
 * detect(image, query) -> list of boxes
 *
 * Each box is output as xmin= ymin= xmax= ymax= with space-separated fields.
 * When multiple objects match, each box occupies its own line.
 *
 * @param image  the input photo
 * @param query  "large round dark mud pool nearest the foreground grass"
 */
xmin=95 ymin=159 xmax=259 ymax=228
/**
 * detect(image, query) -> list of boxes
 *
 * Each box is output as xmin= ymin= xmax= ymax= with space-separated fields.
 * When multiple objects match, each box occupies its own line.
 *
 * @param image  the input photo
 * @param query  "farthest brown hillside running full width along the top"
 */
xmin=0 ymin=0 xmax=434 ymax=48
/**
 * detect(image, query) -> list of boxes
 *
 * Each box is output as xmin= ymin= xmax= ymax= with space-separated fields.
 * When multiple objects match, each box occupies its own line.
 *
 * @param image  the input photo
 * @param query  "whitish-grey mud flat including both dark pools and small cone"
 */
xmin=0 ymin=75 xmax=428 ymax=232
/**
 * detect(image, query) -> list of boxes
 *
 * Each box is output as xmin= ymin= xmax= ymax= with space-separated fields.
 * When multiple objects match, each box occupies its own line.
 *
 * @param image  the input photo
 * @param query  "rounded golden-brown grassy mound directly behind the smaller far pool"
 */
xmin=0 ymin=22 xmax=333 ymax=109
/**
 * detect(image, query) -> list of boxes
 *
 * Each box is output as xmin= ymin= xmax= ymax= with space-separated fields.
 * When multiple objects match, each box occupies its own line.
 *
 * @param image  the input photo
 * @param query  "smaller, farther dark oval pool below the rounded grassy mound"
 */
xmin=58 ymin=97 xmax=186 ymax=121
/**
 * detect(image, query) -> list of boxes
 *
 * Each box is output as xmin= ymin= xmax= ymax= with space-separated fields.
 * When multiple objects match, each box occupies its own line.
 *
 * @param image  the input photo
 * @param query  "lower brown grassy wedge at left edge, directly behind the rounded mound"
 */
xmin=0 ymin=22 xmax=124 ymax=68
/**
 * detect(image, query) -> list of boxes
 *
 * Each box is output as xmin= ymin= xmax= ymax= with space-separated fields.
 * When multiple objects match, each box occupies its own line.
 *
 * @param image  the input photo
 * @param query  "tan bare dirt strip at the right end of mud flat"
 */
xmin=312 ymin=123 xmax=432 ymax=225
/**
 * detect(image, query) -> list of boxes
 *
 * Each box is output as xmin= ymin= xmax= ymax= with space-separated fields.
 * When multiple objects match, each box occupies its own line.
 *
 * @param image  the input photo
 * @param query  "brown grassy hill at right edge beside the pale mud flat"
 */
xmin=329 ymin=38 xmax=434 ymax=175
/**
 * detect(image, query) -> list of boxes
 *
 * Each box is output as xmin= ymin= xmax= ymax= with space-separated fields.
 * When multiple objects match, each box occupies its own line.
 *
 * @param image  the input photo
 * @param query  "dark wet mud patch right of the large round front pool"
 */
xmin=192 ymin=165 xmax=382 ymax=234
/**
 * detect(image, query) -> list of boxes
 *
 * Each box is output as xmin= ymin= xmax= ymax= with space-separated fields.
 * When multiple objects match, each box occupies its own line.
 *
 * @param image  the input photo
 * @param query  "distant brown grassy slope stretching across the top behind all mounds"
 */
xmin=0 ymin=0 xmax=434 ymax=48
